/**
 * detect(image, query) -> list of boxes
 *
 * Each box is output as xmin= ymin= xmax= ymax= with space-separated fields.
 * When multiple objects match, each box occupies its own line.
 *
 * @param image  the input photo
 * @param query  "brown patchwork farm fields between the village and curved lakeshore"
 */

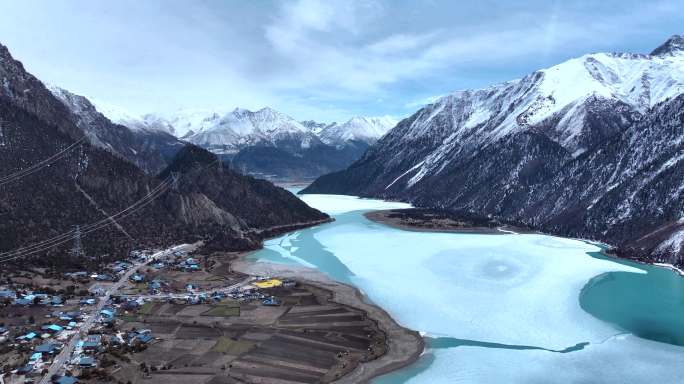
xmin=115 ymin=285 xmax=386 ymax=384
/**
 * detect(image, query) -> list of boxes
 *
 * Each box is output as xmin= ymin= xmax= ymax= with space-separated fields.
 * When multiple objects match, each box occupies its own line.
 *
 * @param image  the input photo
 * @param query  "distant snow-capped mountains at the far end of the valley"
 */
xmin=93 ymin=104 xmax=396 ymax=180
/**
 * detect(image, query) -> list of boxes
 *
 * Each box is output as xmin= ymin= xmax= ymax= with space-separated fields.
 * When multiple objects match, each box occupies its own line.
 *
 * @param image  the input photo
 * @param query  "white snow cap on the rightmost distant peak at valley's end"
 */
xmin=318 ymin=116 xmax=397 ymax=145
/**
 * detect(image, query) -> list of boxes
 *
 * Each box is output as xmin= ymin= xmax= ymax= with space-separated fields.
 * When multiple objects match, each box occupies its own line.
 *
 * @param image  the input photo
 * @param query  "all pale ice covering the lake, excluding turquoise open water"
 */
xmin=256 ymin=195 xmax=684 ymax=383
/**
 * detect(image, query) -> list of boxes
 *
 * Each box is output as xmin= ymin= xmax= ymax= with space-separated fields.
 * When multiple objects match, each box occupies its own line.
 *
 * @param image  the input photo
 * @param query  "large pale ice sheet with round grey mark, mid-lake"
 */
xmin=315 ymin=220 xmax=639 ymax=349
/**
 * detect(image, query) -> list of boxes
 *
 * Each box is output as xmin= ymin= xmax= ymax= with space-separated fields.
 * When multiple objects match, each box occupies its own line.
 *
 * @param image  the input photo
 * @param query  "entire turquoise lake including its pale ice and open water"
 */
xmin=250 ymin=195 xmax=684 ymax=384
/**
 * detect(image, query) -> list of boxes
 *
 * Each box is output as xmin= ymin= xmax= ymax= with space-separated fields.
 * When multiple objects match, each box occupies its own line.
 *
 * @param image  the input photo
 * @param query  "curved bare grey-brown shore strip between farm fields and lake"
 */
xmin=232 ymin=252 xmax=425 ymax=384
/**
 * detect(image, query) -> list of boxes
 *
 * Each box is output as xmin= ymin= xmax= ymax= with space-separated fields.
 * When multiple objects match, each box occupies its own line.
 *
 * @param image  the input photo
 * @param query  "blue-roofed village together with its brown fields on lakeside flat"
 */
xmin=0 ymin=245 xmax=385 ymax=384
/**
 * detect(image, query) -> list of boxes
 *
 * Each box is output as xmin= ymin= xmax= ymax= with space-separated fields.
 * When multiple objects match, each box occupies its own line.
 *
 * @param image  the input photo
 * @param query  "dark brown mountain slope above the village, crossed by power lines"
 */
xmin=0 ymin=45 xmax=327 ymax=268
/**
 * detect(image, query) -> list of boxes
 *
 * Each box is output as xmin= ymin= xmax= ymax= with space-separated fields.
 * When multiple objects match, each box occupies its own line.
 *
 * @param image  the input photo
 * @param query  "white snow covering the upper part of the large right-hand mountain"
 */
xmin=380 ymin=39 xmax=684 ymax=185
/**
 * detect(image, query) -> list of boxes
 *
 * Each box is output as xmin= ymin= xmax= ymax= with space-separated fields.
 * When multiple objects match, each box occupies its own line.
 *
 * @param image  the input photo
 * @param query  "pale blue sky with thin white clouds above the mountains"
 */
xmin=0 ymin=0 xmax=684 ymax=121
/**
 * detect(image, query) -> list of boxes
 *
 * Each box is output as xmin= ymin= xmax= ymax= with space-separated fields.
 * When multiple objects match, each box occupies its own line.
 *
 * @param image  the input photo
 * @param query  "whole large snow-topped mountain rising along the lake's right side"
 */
xmin=303 ymin=36 xmax=684 ymax=266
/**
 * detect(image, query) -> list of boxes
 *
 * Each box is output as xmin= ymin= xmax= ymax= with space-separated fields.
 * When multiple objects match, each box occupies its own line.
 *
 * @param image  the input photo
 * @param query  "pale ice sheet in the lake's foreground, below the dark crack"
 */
xmin=404 ymin=334 xmax=682 ymax=384
